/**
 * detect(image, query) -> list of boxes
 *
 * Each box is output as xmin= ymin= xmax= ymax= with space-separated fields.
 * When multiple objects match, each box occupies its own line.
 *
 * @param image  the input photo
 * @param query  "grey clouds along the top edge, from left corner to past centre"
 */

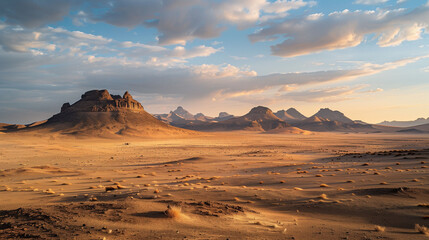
xmin=0 ymin=0 xmax=315 ymax=45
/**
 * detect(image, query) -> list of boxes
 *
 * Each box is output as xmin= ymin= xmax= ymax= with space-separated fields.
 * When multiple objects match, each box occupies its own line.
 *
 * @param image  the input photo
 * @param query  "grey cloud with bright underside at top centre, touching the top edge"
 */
xmin=92 ymin=0 xmax=314 ymax=45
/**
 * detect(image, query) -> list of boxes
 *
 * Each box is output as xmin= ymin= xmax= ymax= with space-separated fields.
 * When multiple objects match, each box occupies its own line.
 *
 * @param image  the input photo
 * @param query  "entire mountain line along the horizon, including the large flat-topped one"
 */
xmin=0 ymin=90 xmax=429 ymax=137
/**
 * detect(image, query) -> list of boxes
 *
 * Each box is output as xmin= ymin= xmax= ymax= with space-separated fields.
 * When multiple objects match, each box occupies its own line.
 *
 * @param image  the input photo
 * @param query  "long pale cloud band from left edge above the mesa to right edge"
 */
xmin=0 ymin=20 xmax=428 ymax=99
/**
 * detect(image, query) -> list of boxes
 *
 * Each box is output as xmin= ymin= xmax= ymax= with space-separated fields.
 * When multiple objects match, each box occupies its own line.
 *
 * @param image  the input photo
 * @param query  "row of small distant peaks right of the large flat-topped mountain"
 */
xmin=155 ymin=106 xmax=386 ymax=132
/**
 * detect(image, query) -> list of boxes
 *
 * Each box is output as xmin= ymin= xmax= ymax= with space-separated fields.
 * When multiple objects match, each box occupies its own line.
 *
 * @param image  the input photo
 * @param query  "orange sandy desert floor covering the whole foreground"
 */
xmin=0 ymin=132 xmax=429 ymax=239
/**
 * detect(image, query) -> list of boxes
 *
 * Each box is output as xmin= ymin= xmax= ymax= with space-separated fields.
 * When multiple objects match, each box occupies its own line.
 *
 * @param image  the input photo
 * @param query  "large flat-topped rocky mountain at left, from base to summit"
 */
xmin=10 ymin=90 xmax=194 ymax=137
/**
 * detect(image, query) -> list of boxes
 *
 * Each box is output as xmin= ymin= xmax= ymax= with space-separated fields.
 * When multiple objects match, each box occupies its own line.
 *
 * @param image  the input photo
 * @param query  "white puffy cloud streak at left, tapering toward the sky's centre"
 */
xmin=0 ymin=22 xmax=223 ymax=66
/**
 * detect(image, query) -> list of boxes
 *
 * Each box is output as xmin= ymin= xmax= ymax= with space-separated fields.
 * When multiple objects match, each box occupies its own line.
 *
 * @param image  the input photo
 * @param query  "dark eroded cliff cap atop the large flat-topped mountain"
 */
xmin=61 ymin=90 xmax=144 ymax=113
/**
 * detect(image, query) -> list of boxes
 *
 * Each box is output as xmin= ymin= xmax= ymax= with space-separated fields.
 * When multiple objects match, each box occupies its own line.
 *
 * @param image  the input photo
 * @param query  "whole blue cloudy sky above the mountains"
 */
xmin=0 ymin=0 xmax=429 ymax=123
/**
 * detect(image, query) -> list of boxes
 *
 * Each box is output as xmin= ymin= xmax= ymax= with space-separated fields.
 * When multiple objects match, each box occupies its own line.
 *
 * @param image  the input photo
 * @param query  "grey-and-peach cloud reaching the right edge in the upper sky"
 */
xmin=249 ymin=4 xmax=429 ymax=57
